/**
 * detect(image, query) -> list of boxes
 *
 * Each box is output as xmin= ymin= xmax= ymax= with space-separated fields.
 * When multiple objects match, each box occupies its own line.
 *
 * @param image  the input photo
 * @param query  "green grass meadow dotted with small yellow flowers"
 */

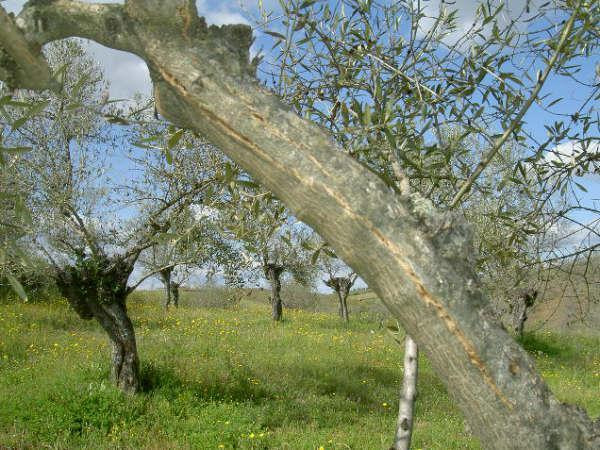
xmin=0 ymin=295 xmax=600 ymax=449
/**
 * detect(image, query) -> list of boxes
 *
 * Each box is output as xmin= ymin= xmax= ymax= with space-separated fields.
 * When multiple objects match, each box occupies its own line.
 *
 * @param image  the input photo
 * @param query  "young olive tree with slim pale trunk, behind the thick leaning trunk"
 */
xmin=263 ymin=1 xmax=591 ymax=448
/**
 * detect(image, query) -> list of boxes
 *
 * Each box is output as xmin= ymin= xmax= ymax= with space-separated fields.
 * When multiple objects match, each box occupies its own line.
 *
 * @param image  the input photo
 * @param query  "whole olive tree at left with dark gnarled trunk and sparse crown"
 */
xmin=3 ymin=40 xmax=225 ymax=392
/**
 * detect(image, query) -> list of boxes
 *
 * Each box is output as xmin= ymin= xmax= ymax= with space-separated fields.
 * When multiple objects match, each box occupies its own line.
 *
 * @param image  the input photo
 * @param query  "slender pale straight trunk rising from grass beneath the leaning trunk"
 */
xmin=391 ymin=334 xmax=419 ymax=450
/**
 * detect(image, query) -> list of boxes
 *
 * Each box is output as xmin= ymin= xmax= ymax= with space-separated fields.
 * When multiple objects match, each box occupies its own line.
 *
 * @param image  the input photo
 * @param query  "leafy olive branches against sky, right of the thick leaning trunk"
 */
xmin=268 ymin=0 xmax=600 ymax=320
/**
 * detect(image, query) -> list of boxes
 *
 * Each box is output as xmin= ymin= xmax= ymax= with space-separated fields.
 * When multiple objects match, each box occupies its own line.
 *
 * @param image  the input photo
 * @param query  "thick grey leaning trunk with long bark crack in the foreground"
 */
xmin=0 ymin=0 xmax=600 ymax=449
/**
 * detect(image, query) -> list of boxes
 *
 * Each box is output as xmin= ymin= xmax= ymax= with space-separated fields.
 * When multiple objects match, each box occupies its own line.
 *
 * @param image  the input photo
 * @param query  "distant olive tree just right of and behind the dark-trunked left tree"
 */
xmin=131 ymin=125 xmax=239 ymax=308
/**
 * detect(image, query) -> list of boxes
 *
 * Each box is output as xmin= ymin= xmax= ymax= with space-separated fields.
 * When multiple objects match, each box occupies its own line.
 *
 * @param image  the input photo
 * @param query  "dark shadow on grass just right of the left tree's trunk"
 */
xmin=140 ymin=362 xmax=272 ymax=404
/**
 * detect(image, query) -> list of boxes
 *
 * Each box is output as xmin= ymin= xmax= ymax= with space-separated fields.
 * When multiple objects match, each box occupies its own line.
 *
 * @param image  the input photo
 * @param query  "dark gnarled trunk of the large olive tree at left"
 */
xmin=56 ymin=258 xmax=140 ymax=393
